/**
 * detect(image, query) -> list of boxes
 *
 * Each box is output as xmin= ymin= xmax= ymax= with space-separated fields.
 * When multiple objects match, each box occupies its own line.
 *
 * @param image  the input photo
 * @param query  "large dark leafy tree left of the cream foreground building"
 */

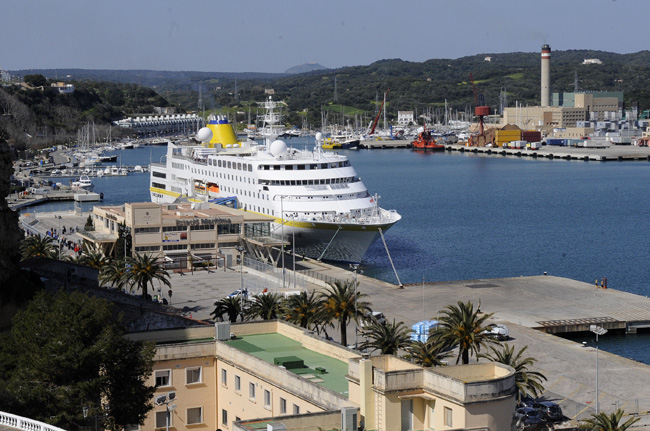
xmin=0 ymin=292 xmax=155 ymax=429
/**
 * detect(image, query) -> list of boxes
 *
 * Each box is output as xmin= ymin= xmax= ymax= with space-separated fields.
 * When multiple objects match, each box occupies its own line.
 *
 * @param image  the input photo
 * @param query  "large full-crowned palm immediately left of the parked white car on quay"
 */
xmin=429 ymin=301 xmax=497 ymax=364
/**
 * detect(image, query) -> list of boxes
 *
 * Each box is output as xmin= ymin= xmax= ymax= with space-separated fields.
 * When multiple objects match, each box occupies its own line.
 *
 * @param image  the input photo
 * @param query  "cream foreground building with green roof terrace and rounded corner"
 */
xmin=131 ymin=321 xmax=516 ymax=431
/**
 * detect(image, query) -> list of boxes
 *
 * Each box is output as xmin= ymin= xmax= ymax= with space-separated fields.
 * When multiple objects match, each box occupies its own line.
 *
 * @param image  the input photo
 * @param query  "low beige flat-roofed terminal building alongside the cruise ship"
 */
xmin=80 ymin=202 xmax=277 ymax=268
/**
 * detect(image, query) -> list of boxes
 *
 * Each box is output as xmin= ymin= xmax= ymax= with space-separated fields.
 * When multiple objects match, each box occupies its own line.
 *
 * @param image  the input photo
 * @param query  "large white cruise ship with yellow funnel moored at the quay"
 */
xmin=150 ymin=98 xmax=401 ymax=263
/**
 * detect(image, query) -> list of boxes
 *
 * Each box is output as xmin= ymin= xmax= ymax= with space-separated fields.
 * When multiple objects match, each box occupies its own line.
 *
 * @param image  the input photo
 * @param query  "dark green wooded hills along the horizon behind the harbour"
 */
xmin=7 ymin=50 xmax=650 ymax=143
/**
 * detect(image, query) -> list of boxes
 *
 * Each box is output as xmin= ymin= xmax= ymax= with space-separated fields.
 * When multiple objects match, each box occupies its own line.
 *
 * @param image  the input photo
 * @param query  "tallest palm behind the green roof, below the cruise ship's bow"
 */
xmin=321 ymin=280 xmax=370 ymax=346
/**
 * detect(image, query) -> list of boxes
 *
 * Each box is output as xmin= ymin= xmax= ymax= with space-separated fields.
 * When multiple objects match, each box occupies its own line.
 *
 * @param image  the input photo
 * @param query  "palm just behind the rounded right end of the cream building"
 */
xmin=479 ymin=343 xmax=546 ymax=402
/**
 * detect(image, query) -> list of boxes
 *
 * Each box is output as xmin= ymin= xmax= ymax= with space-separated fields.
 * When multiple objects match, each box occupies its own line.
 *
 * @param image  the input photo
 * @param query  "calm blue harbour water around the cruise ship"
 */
xmin=24 ymin=139 xmax=650 ymax=364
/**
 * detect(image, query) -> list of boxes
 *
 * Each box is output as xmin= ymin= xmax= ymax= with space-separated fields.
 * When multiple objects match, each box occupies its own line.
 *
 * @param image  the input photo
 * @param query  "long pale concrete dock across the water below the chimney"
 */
xmin=445 ymin=144 xmax=650 ymax=162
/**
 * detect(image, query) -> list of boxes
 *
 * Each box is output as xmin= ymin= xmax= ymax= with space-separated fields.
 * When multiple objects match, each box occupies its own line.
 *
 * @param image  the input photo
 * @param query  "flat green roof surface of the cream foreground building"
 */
xmin=226 ymin=333 xmax=348 ymax=396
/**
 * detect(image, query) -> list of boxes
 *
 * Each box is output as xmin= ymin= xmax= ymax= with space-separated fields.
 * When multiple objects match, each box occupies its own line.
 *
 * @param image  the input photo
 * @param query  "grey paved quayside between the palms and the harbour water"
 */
xmin=172 ymin=262 xmax=650 ymax=430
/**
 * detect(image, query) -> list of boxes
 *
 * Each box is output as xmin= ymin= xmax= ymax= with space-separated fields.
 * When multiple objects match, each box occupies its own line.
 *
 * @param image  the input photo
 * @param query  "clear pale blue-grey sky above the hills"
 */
xmin=0 ymin=0 xmax=650 ymax=73
